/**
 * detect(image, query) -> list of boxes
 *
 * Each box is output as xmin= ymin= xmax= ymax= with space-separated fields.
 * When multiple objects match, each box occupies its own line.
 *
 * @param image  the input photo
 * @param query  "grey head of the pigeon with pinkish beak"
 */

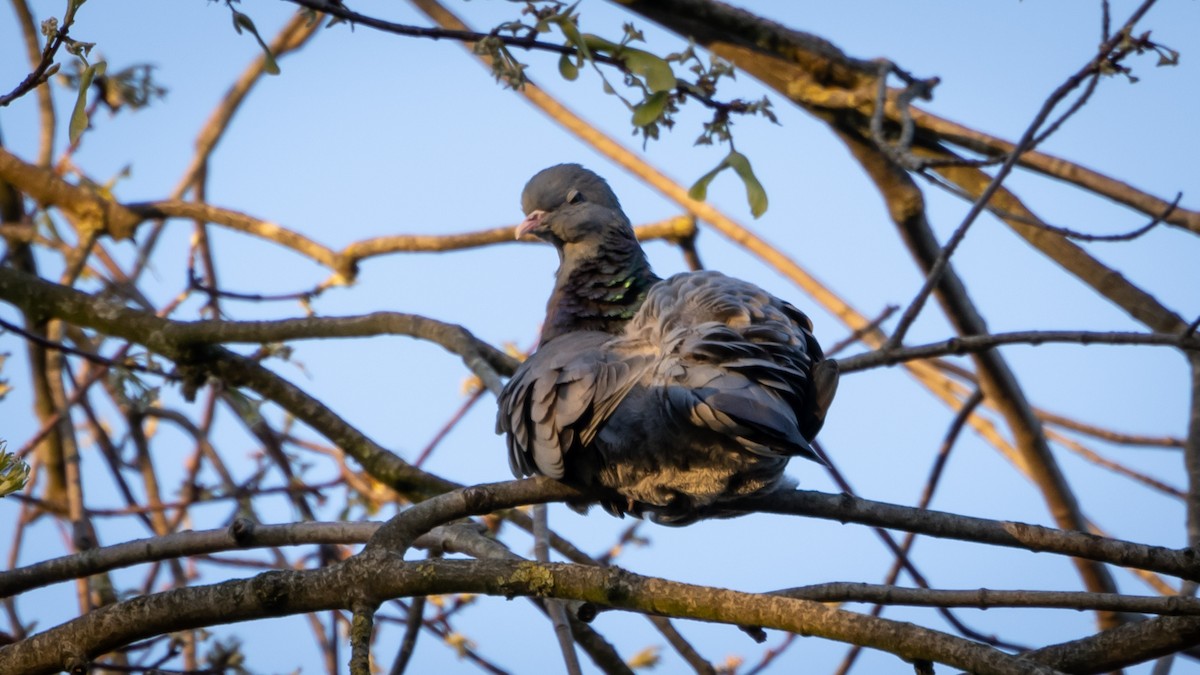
xmin=516 ymin=165 xmax=629 ymax=249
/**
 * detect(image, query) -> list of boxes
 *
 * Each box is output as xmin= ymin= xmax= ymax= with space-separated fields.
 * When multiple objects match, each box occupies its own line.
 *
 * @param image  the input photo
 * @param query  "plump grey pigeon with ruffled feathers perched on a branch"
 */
xmin=497 ymin=163 xmax=838 ymax=525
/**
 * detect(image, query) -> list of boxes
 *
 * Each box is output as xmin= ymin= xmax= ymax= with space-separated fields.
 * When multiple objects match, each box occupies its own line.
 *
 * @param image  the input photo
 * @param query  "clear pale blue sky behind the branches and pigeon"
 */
xmin=0 ymin=0 xmax=1200 ymax=673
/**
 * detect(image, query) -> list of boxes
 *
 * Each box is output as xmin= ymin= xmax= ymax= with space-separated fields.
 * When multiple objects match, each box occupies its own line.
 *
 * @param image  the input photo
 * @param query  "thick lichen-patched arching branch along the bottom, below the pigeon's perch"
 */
xmin=0 ymin=555 xmax=1056 ymax=675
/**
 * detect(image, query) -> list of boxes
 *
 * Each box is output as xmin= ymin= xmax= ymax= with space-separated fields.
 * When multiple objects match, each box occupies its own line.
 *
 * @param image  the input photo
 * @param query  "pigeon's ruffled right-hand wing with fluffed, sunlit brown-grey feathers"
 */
xmin=626 ymin=271 xmax=836 ymax=461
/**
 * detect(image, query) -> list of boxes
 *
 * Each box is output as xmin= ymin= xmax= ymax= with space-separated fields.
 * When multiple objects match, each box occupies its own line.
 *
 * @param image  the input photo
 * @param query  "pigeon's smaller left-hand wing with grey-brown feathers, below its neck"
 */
xmin=496 ymin=330 xmax=644 ymax=479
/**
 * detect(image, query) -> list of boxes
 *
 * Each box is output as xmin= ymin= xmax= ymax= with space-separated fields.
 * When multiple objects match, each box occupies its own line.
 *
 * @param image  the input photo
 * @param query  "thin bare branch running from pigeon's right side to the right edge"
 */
xmin=838 ymin=330 xmax=1200 ymax=372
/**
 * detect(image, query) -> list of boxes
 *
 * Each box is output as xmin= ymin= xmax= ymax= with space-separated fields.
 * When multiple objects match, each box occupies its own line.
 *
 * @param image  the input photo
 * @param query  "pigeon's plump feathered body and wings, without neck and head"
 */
xmin=499 ymin=271 xmax=836 ymax=524
